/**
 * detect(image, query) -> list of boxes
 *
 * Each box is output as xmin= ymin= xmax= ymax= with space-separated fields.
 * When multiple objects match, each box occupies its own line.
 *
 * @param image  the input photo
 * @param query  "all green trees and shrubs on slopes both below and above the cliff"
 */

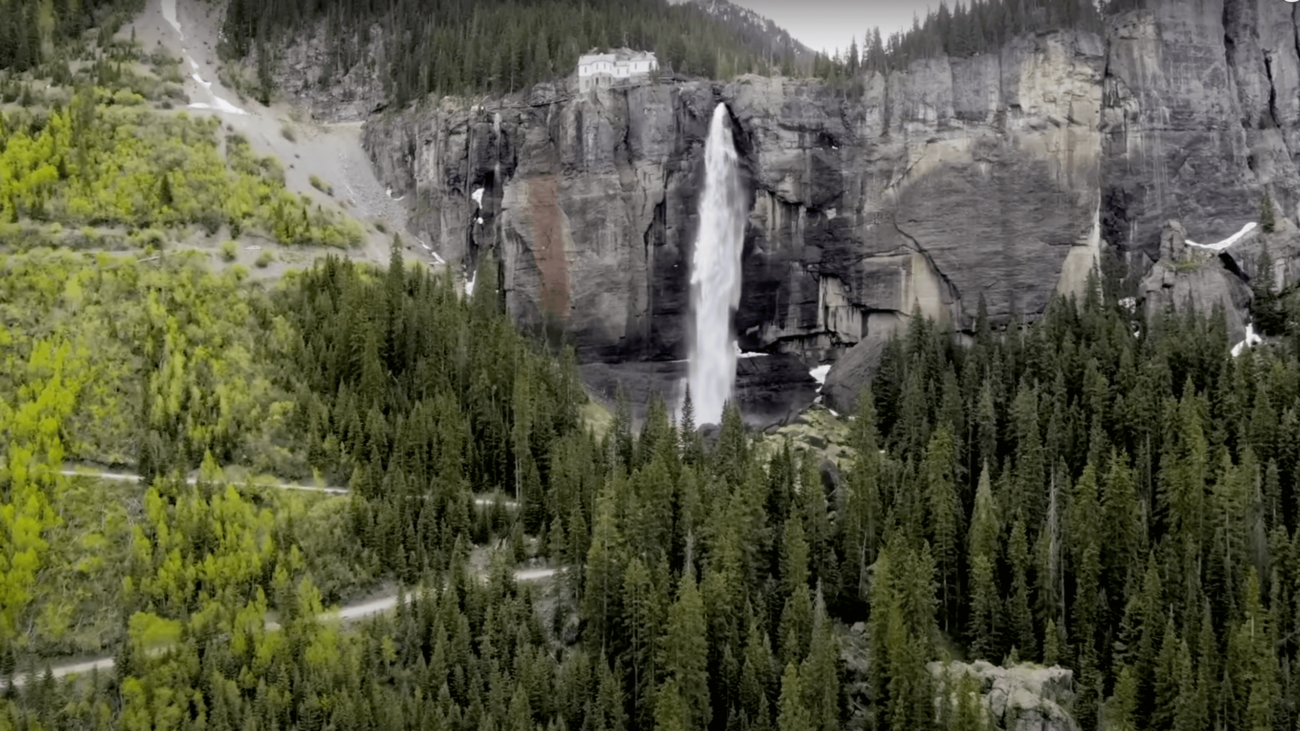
xmin=0 ymin=0 xmax=1300 ymax=731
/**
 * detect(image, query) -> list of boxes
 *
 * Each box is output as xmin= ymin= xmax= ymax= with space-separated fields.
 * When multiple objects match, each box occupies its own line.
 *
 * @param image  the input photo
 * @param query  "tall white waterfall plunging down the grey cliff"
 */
xmin=689 ymin=104 xmax=746 ymax=424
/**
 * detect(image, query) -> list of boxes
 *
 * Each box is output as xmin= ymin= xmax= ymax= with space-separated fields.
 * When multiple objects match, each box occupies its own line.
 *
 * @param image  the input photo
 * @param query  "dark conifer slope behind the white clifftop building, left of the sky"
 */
xmin=225 ymin=0 xmax=811 ymax=104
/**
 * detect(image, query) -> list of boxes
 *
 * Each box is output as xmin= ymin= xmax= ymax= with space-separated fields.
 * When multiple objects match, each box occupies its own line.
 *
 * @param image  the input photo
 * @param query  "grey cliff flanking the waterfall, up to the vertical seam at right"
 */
xmin=365 ymin=34 xmax=1101 ymax=390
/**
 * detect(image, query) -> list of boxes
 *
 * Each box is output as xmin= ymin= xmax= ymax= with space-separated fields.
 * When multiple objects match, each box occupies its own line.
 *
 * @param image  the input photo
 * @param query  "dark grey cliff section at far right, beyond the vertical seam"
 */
xmin=1101 ymin=0 xmax=1300 ymax=259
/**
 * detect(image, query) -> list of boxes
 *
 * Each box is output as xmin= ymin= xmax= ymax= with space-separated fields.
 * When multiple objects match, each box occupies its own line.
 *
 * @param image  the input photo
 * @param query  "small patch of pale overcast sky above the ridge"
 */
xmin=731 ymin=0 xmax=930 ymax=53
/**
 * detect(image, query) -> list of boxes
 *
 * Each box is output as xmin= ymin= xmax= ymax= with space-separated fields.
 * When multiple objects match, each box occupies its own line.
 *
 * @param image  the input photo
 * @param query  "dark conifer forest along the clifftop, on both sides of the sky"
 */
xmin=213 ymin=0 xmax=1118 ymax=105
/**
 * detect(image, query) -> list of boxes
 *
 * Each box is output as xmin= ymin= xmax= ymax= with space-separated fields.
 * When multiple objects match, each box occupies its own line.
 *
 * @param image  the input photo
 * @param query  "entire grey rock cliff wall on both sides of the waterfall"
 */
xmin=365 ymin=0 xmax=1300 ymax=407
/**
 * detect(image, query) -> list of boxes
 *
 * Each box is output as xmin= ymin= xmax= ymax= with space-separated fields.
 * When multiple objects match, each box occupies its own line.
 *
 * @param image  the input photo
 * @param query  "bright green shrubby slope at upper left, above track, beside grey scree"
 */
xmin=0 ymin=88 xmax=361 ymax=247
